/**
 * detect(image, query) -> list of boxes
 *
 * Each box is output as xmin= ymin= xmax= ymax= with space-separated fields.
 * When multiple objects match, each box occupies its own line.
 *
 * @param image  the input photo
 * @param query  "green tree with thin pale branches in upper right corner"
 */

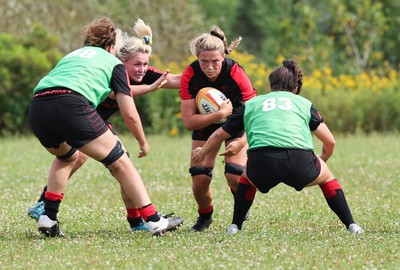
xmin=332 ymin=0 xmax=388 ymax=72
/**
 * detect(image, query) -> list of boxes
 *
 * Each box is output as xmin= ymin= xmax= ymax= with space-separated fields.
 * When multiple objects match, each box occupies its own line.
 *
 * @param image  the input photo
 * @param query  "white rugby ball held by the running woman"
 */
xmin=196 ymin=87 xmax=226 ymax=123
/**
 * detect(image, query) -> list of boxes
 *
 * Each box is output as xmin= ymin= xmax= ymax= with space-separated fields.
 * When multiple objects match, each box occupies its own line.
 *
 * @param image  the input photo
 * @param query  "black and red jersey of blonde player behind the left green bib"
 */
xmin=97 ymin=66 xmax=164 ymax=121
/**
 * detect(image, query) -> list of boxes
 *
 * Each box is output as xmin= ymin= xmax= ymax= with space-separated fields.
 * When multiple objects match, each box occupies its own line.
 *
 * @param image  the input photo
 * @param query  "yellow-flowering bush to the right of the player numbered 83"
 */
xmin=302 ymin=65 xmax=400 ymax=133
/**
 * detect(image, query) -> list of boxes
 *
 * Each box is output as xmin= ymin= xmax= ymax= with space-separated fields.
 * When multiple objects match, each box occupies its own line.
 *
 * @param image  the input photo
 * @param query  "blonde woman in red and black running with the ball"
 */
xmin=180 ymin=27 xmax=256 ymax=232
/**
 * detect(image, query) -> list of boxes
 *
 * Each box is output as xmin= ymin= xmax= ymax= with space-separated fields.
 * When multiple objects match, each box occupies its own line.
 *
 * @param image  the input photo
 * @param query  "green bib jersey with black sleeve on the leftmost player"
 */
xmin=34 ymin=46 xmax=130 ymax=107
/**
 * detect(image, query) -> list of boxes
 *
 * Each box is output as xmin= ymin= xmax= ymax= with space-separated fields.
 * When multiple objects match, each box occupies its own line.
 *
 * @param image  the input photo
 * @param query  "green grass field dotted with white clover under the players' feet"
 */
xmin=0 ymin=134 xmax=400 ymax=269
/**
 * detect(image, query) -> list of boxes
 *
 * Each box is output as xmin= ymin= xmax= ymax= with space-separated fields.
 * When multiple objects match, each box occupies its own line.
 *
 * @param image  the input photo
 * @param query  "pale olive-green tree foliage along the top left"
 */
xmin=0 ymin=0 xmax=204 ymax=61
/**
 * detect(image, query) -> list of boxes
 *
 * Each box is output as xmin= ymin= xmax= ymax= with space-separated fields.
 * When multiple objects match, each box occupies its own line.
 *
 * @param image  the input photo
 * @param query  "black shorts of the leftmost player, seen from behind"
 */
xmin=29 ymin=93 xmax=108 ymax=149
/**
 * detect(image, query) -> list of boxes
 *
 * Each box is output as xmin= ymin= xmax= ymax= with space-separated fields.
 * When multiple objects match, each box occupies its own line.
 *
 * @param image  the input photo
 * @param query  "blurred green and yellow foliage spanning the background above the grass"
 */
xmin=0 ymin=0 xmax=400 ymax=136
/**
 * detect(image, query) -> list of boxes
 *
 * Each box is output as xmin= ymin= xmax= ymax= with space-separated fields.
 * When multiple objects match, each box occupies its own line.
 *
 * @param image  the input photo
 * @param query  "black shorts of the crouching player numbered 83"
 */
xmin=246 ymin=147 xmax=321 ymax=193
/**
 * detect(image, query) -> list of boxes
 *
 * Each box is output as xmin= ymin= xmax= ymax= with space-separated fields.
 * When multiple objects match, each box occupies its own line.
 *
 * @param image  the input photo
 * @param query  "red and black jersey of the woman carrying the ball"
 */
xmin=179 ymin=58 xmax=256 ymax=137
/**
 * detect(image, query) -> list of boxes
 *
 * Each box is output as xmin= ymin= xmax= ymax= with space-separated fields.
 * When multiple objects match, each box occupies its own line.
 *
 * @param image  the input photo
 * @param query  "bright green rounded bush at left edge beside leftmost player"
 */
xmin=0 ymin=28 xmax=61 ymax=135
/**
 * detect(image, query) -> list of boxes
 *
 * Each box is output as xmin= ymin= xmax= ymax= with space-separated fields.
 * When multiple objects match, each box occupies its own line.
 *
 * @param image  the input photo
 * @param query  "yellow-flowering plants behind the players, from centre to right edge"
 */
xmin=145 ymin=51 xmax=400 ymax=136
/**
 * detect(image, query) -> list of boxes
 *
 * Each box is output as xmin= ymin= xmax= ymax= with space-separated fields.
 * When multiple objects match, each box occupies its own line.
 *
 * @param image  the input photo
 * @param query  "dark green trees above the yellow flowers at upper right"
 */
xmin=228 ymin=0 xmax=390 ymax=73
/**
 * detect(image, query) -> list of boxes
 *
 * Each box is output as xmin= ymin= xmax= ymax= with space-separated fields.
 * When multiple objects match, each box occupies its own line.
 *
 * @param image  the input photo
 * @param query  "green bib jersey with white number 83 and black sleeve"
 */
xmin=244 ymin=91 xmax=323 ymax=150
